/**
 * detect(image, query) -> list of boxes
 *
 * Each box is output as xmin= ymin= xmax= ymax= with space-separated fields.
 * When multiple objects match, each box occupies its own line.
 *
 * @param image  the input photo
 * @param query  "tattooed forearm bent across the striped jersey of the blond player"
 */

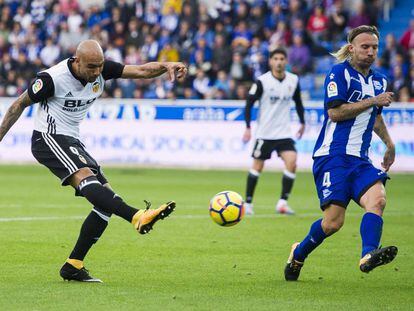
xmin=328 ymin=92 xmax=394 ymax=122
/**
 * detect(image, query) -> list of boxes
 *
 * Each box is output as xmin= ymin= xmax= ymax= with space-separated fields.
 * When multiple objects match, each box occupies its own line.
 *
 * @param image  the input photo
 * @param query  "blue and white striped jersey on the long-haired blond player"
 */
xmin=313 ymin=61 xmax=387 ymax=158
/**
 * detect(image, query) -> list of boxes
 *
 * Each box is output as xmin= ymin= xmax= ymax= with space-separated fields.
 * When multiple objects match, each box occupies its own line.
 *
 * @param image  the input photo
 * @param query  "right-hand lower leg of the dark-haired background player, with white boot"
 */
xmin=276 ymin=150 xmax=297 ymax=215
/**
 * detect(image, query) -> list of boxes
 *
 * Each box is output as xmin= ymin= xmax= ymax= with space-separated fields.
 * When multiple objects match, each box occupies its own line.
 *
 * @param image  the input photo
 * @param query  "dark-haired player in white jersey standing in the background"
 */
xmin=243 ymin=48 xmax=305 ymax=215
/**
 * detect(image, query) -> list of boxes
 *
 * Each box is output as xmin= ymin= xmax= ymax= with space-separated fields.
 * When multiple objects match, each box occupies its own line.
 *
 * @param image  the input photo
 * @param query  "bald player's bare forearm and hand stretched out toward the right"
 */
xmin=121 ymin=62 xmax=187 ymax=82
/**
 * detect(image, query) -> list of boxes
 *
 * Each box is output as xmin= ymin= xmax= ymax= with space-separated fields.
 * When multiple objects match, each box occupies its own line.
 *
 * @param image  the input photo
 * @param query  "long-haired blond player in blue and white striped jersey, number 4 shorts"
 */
xmin=285 ymin=25 xmax=398 ymax=281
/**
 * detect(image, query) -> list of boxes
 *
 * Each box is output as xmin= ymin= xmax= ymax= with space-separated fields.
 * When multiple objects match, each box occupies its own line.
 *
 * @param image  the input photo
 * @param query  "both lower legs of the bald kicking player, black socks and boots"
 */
xmin=60 ymin=168 xmax=175 ymax=282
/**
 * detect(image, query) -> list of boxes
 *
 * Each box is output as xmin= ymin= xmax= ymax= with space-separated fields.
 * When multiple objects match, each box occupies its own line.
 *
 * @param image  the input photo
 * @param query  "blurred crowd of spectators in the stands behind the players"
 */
xmin=0 ymin=0 xmax=414 ymax=101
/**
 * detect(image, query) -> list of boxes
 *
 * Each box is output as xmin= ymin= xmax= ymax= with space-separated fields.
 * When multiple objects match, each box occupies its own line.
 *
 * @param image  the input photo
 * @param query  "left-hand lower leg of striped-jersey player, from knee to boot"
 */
xmin=285 ymin=204 xmax=345 ymax=281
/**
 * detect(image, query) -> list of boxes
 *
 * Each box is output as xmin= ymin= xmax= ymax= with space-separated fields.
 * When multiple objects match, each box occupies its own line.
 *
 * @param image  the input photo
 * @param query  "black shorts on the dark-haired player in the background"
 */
xmin=252 ymin=138 xmax=296 ymax=160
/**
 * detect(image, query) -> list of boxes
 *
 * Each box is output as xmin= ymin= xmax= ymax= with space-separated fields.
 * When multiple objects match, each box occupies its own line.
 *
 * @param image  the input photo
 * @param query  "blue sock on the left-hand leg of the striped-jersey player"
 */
xmin=293 ymin=219 xmax=327 ymax=262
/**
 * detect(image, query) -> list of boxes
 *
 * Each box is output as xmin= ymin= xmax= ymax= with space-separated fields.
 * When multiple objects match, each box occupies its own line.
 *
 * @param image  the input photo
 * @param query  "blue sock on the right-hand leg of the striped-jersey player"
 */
xmin=360 ymin=213 xmax=383 ymax=258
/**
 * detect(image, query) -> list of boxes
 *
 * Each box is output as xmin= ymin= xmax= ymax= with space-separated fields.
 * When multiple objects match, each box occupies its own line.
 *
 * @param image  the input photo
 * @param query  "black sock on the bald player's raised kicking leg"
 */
xmin=78 ymin=176 xmax=138 ymax=222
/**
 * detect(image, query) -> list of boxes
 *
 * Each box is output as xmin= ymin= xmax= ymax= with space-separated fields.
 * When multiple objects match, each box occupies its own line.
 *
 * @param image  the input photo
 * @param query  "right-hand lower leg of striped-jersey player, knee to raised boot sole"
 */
xmin=359 ymin=181 xmax=398 ymax=273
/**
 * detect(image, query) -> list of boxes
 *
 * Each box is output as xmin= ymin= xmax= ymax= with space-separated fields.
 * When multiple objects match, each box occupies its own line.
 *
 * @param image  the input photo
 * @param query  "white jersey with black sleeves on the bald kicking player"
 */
xmin=28 ymin=58 xmax=124 ymax=138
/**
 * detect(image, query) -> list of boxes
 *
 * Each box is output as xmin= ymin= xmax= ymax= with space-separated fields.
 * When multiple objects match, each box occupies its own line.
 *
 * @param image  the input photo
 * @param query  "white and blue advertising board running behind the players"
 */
xmin=0 ymin=99 xmax=414 ymax=172
